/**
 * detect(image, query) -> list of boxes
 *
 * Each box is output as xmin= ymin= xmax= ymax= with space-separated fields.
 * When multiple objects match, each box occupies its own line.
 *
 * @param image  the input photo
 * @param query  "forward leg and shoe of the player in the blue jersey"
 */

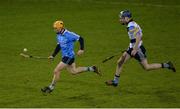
xmin=41 ymin=62 xmax=67 ymax=93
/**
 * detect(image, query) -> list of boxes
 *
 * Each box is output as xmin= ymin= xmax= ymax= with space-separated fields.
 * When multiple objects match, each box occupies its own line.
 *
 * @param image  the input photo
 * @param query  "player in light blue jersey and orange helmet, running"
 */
xmin=41 ymin=20 xmax=101 ymax=93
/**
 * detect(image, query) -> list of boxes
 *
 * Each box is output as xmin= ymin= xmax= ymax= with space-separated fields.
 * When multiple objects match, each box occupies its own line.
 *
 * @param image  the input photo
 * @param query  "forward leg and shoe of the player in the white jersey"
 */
xmin=106 ymin=52 xmax=131 ymax=86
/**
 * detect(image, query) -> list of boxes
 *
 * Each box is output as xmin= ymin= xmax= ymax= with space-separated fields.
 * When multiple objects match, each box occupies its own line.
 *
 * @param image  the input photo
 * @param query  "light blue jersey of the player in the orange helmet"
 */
xmin=57 ymin=30 xmax=80 ymax=58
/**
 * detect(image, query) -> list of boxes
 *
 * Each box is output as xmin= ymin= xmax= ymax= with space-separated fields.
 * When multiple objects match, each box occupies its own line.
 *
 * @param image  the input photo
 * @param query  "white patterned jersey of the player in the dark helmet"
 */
xmin=127 ymin=21 xmax=142 ymax=48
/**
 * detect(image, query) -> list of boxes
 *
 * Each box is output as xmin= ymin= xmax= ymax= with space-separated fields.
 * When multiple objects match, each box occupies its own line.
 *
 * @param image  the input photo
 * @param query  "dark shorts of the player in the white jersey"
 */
xmin=126 ymin=45 xmax=147 ymax=62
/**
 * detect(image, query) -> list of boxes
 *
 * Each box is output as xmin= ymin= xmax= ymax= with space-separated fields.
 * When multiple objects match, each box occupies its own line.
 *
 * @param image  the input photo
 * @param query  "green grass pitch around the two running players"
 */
xmin=0 ymin=0 xmax=180 ymax=108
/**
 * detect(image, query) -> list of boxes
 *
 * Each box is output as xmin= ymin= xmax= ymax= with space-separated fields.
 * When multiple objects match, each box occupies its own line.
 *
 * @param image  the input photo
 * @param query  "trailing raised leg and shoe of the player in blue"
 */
xmin=67 ymin=63 xmax=100 ymax=75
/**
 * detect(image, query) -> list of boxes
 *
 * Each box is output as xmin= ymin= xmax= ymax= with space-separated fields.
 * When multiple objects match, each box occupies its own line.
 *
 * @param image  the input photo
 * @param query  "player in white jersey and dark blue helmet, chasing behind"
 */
xmin=106 ymin=10 xmax=176 ymax=86
